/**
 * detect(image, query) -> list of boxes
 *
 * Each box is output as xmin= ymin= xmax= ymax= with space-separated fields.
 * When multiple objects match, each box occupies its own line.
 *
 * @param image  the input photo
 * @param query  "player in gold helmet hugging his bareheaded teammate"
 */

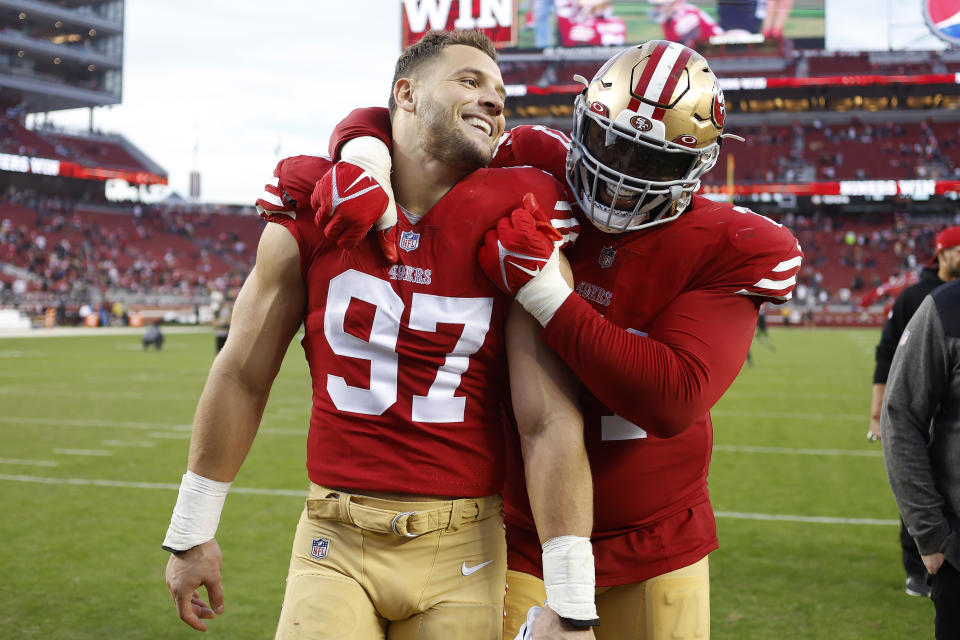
xmin=318 ymin=41 xmax=802 ymax=640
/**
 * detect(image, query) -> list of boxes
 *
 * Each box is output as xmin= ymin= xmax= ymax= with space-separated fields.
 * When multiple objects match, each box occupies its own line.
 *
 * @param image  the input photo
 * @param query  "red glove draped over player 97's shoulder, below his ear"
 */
xmin=310 ymin=160 xmax=398 ymax=262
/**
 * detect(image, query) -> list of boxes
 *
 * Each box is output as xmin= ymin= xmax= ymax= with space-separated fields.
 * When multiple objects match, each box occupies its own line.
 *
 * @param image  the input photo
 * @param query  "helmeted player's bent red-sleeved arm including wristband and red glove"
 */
xmin=479 ymin=208 xmax=760 ymax=438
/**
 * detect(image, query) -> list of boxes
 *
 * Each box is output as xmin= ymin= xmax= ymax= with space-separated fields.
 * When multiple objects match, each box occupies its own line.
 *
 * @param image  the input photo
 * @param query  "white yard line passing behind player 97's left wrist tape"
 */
xmin=0 ymin=474 xmax=900 ymax=526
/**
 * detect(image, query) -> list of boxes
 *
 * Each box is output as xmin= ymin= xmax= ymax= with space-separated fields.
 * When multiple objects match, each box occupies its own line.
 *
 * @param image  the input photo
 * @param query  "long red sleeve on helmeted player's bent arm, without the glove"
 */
xmin=542 ymin=290 xmax=758 ymax=438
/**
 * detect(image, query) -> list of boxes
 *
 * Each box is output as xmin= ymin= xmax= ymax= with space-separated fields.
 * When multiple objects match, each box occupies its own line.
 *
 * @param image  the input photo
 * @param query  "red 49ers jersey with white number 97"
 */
xmin=257 ymin=156 xmax=571 ymax=497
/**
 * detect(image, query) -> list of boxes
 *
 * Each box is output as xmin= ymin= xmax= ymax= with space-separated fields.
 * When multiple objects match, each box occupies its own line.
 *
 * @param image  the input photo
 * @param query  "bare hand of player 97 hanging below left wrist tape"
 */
xmin=166 ymin=540 xmax=224 ymax=631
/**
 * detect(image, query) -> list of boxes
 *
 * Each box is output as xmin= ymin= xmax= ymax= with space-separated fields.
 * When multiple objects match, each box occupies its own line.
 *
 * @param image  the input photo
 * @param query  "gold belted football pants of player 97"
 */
xmin=276 ymin=485 xmax=506 ymax=640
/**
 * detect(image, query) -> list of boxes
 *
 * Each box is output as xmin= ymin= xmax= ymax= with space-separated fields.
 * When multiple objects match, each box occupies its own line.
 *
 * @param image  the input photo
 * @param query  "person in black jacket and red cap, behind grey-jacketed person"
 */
xmin=867 ymin=227 xmax=960 ymax=596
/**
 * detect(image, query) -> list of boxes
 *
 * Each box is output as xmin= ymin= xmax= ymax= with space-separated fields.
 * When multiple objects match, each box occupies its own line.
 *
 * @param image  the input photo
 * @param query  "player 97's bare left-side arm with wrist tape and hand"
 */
xmin=163 ymin=224 xmax=305 ymax=631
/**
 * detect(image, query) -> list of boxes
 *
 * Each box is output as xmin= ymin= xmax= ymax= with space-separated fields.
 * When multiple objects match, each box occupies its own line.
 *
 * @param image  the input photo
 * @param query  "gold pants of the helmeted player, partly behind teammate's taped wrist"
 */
xmin=503 ymin=557 xmax=710 ymax=640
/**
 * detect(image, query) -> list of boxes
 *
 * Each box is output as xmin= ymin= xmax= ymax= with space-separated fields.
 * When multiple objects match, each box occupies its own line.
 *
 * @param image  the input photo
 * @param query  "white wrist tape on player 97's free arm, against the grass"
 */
xmin=163 ymin=470 xmax=230 ymax=553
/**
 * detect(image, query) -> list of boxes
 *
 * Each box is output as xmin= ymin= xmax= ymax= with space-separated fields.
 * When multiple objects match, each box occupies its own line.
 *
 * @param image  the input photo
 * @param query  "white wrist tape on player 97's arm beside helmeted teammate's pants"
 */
xmin=543 ymin=536 xmax=599 ymax=626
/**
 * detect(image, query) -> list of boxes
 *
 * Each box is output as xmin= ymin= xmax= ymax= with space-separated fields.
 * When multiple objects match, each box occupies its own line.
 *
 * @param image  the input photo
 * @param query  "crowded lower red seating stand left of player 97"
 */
xmin=0 ymin=197 xmax=262 ymax=303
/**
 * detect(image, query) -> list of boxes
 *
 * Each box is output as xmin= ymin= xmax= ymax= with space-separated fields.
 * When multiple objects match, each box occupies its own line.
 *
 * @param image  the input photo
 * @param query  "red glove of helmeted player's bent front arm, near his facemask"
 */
xmin=479 ymin=193 xmax=563 ymax=295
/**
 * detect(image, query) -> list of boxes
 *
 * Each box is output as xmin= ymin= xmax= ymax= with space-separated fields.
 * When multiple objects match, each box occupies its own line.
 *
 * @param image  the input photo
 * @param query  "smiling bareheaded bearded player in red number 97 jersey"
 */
xmin=163 ymin=32 xmax=596 ymax=640
